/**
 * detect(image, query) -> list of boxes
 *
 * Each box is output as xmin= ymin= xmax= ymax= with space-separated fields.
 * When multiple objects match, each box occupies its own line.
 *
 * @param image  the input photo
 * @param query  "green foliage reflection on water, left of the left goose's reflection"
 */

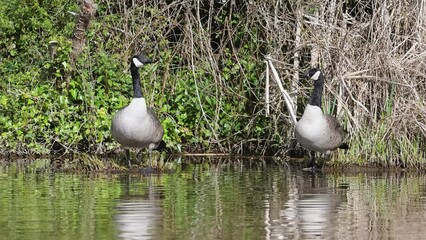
xmin=0 ymin=161 xmax=122 ymax=239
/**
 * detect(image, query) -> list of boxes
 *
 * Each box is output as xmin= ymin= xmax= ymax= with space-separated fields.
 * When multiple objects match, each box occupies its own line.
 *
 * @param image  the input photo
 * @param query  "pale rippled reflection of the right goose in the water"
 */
xmin=266 ymin=174 xmax=344 ymax=239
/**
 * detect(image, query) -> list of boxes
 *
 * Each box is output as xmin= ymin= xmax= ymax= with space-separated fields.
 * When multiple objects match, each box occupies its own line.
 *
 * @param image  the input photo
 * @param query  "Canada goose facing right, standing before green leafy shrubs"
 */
xmin=111 ymin=54 xmax=165 ymax=167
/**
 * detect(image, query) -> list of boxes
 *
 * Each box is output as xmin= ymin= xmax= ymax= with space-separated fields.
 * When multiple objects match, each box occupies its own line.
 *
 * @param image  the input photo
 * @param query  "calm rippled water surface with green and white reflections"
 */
xmin=0 ymin=158 xmax=426 ymax=240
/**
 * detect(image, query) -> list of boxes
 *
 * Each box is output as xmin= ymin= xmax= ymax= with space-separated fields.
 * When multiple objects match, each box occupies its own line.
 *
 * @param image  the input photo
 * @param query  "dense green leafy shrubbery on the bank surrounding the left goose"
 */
xmin=0 ymin=0 xmax=280 ymax=154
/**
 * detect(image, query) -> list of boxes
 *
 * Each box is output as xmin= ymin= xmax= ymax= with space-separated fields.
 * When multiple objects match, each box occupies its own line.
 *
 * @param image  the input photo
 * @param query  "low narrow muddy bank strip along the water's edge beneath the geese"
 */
xmin=0 ymin=153 xmax=426 ymax=174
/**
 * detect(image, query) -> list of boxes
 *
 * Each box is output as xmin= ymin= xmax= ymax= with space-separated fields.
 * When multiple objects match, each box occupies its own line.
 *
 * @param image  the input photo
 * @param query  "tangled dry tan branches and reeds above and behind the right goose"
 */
xmin=99 ymin=0 xmax=426 ymax=154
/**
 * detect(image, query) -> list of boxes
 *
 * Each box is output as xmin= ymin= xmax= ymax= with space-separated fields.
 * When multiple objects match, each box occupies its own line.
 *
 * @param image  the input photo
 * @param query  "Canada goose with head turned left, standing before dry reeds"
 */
xmin=295 ymin=68 xmax=349 ymax=169
